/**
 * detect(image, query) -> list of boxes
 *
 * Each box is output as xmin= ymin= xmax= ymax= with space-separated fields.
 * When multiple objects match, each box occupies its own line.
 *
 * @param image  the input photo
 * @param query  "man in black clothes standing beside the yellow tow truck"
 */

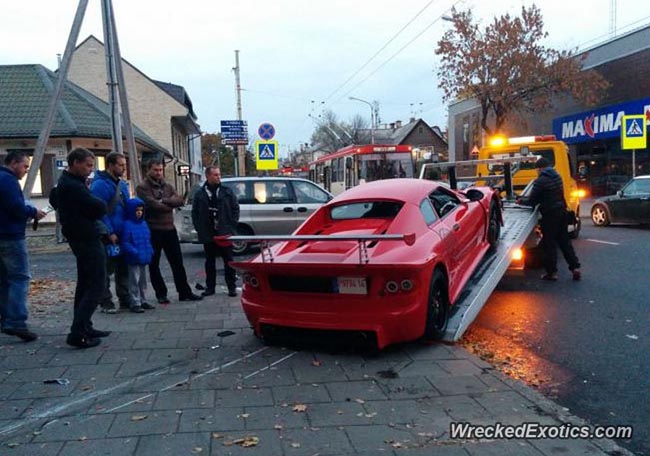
xmin=520 ymin=158 xmax=581 ymax=281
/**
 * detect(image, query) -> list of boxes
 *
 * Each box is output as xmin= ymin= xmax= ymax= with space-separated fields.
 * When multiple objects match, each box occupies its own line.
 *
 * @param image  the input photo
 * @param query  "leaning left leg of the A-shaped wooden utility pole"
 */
xmin=23 ymin=0 xmax=88 ymax=198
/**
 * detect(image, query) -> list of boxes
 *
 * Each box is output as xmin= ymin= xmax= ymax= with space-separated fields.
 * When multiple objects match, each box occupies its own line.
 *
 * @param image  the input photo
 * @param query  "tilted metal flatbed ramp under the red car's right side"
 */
xmin=443 ymin=203 xmax=537 ymax=342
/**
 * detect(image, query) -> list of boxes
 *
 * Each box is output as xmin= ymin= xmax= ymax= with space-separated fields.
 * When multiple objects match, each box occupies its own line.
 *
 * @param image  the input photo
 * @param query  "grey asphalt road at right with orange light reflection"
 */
xmin=468 ymin=220 xmax=650 ymax=455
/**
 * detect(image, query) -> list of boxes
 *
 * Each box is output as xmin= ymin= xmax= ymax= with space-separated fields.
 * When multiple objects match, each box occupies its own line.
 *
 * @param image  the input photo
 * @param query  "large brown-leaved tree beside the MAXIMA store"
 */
xmin=435 ymin=5 xmax=609 ymax=134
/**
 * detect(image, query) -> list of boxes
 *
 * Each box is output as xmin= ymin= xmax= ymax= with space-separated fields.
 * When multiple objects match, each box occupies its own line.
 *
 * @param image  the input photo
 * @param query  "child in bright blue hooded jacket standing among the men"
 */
xmin=120 ymin=198 xmax=155 ymax=313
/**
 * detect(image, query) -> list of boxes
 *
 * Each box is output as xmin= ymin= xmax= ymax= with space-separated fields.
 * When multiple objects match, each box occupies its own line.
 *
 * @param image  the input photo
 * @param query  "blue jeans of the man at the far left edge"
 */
xmin=0 ymin=239 xmax=31 ymax=329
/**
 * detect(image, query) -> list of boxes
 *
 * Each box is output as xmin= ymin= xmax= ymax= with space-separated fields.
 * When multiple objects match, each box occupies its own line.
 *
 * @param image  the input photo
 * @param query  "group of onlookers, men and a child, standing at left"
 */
xmin=0 ymin=148 xmax=239 ymax=348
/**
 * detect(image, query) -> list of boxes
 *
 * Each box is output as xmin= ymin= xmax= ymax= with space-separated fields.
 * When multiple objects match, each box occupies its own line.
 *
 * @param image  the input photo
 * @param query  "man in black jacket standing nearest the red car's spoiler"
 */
xmin=192 ymin=166 xmax=239 ymax=297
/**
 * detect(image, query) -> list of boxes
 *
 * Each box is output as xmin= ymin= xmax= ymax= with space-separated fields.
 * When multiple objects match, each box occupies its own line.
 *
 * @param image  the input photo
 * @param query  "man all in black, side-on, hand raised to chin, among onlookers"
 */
xmin=56 ymin=148 xmax=110 ymax=348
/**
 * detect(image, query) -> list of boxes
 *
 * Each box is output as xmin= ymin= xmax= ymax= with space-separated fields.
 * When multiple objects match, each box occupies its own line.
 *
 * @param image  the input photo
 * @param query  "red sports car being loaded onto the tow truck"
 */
xmin=227 ymin=179 xmax=502 ymax=348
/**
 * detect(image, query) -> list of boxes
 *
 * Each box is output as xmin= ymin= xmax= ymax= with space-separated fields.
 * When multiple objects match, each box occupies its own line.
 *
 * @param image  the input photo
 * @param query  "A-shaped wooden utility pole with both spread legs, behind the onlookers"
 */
xmin=23 ymin=0 xmax=141 ymax=197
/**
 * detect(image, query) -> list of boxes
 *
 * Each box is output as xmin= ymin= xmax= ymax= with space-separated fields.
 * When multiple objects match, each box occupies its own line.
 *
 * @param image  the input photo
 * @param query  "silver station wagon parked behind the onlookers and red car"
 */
xmin=176 ymin=177 xmax=332 ymax=254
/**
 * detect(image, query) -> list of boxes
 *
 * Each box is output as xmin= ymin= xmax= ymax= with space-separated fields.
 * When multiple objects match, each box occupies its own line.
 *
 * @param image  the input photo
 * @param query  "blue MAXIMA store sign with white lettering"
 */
xmin=553 ymin=98 xmax=650 ymax=144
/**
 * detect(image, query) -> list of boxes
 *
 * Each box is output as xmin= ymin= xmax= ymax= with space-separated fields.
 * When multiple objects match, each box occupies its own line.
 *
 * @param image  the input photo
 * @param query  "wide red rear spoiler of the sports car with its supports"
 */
xmin=213 ymin=233 xmax=415 ymax=264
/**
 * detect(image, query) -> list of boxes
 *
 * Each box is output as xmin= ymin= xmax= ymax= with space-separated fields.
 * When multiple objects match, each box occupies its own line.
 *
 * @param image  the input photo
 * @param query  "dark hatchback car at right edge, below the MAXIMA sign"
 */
xmin=591 ymin=175 xmax=650 ymax=226
